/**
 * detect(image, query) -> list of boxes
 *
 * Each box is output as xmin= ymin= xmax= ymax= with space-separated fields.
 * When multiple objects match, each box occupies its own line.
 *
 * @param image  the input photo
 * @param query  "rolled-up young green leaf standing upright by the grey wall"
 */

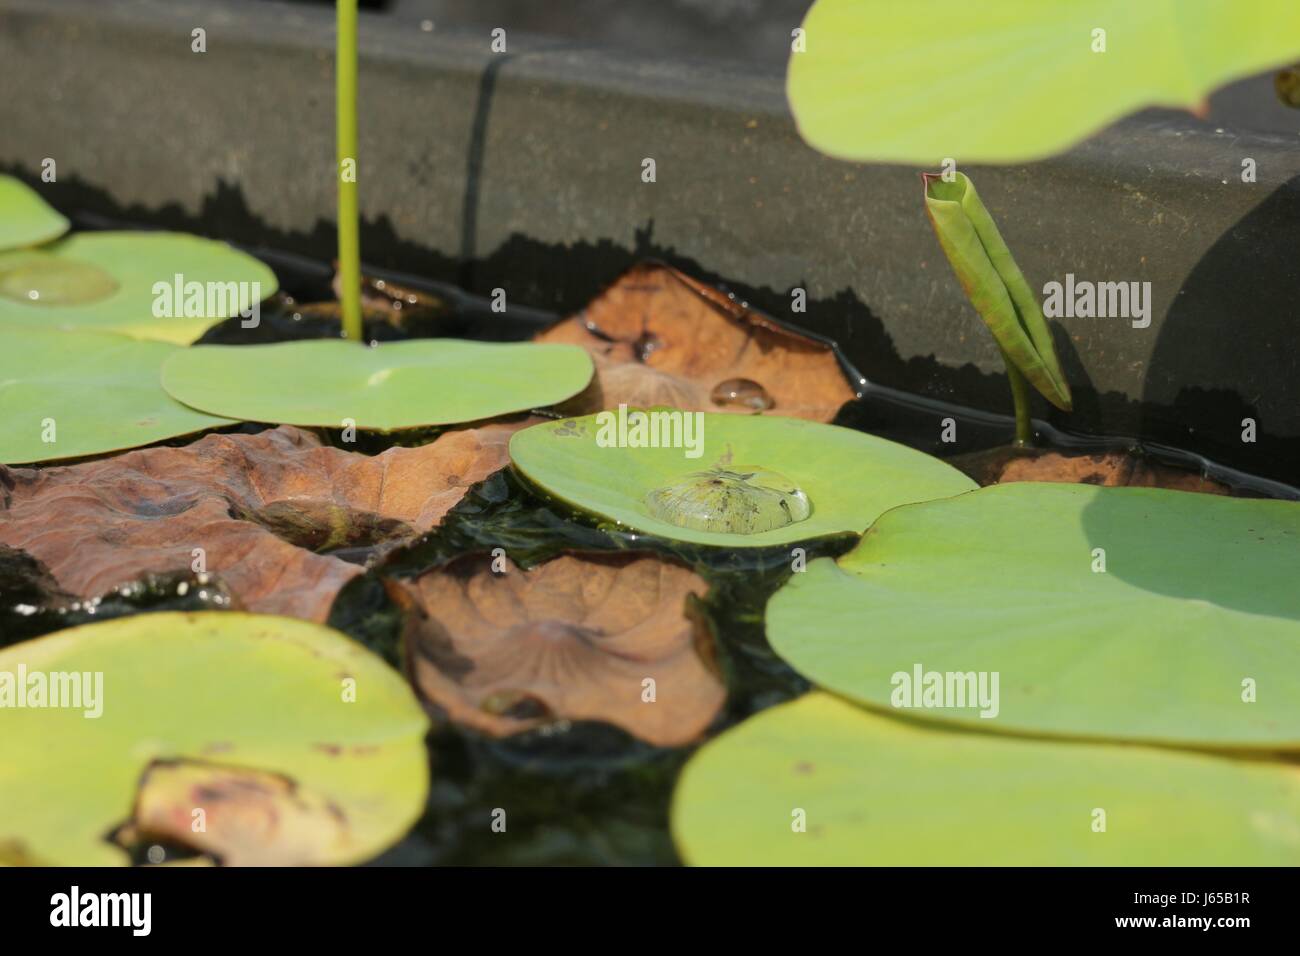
xmin=924 ymin=173 xmax=1070 ymax=411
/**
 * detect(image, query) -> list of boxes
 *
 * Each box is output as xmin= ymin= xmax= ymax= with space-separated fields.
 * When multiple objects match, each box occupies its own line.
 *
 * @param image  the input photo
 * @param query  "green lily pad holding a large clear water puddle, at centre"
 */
xmin=510 ymin=408 xmax=975 ymax=548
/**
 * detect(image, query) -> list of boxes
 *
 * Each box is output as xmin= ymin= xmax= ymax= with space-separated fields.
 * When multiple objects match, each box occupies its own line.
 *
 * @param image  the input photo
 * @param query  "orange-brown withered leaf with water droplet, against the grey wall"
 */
xmin=537 ymin=263 xmax=854 ymax=421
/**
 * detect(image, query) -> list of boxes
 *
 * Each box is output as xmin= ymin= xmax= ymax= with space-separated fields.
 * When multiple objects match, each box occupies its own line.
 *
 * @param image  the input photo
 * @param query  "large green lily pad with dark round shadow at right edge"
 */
xmin=767 ymin=483 xmax=1300 ymax=749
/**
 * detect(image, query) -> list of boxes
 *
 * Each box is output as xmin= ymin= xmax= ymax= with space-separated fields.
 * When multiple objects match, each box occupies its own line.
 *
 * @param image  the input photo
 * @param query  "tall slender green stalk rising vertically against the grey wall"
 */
xmin=334 ymin=0 xmax=361 ymax=342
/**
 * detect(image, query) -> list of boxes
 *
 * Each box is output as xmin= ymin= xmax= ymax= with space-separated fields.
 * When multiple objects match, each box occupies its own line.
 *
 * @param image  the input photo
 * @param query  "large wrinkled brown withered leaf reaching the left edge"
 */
xmin=0 ymin=419 xmax=532 ymax=620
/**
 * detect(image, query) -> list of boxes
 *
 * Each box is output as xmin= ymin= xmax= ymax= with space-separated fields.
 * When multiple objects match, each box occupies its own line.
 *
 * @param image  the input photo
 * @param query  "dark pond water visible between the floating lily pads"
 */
xmin=0 ymin=244 xmax=1300 ymax=865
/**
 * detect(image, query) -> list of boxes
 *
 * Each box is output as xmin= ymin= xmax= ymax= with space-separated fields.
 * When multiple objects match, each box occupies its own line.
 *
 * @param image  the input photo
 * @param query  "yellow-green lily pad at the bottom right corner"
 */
xmin=672 ymin=692 xmax=1300 ymax=866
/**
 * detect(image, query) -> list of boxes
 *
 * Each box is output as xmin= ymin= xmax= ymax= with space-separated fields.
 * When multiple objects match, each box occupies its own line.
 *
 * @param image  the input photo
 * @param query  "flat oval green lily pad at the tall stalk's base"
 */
xmin=163 ymin=338 xmax=592 ymax=432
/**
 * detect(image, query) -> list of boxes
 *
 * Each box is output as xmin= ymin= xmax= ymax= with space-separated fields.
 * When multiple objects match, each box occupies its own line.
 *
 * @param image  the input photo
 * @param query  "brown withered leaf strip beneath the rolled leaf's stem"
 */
xmin=948 ymin=446 xmax=1232 ymax=494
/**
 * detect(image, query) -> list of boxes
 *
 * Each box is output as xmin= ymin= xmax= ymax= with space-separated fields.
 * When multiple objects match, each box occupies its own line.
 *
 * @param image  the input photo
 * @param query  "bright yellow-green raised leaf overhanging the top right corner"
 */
xmin=787 ymin=0 xmax=1300 ymax=165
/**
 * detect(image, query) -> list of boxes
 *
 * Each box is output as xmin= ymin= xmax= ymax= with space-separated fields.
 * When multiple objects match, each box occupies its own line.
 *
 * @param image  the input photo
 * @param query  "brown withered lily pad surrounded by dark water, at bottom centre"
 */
xmin=406 ymin=553 xmax=725 ymax=747
